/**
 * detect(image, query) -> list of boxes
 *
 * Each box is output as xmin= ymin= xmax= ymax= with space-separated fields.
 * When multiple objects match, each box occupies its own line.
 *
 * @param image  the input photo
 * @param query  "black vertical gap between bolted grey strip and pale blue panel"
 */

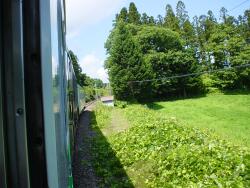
xmin=22 ymin=0 xmax=48 ymax=188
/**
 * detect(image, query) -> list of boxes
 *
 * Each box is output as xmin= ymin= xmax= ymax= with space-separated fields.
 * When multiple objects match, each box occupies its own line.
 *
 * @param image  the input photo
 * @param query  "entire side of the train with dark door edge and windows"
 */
xmin=0 ymin=0 xmax=84 ymax=188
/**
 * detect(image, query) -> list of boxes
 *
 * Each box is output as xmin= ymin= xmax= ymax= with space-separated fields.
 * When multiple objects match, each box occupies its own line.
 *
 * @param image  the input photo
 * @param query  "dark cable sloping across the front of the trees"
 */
xmin=128 ymin=64 xmax=250 ymax=83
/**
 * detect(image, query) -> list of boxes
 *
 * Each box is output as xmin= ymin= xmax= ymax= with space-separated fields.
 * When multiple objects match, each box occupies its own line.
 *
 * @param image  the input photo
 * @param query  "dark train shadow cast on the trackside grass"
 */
xmin=91 ymin=112 xmax=134 ymax=188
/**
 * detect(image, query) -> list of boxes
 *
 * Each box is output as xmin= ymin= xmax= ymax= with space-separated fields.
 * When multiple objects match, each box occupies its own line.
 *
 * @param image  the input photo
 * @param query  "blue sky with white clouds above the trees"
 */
xmin=66 ymin=0 xmax=250 ymax=82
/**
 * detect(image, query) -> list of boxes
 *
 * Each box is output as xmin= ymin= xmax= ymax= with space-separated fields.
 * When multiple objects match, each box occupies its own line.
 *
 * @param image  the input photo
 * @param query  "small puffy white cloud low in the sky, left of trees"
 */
xmin=79 ymin=53 xmax=108 ymax=82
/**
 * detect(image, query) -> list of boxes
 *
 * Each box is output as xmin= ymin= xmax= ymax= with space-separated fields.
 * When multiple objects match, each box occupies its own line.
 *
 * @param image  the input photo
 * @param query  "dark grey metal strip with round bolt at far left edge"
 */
xmin=0 ymin=0 xmax=30 ymax=188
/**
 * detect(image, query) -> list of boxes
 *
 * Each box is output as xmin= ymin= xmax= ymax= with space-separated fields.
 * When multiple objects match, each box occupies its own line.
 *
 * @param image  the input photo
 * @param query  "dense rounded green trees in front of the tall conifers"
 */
xmin=105 ymin=22 xmax=202 ymax=101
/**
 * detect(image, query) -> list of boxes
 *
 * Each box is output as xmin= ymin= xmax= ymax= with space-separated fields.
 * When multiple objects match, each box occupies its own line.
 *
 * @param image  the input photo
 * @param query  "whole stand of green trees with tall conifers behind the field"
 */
xmin=105 ymin=1 xmax=250 ymax=100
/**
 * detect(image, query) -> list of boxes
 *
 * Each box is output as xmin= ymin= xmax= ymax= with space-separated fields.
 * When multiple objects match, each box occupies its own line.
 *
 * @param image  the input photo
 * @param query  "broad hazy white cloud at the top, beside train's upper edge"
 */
xmin=66 ymin=0 xmax=123 ymax=33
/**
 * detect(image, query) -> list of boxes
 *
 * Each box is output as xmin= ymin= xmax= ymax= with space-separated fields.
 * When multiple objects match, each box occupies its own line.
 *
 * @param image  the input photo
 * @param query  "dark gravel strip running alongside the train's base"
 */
xmin=73 ymin=103 xmax=98 ymax=188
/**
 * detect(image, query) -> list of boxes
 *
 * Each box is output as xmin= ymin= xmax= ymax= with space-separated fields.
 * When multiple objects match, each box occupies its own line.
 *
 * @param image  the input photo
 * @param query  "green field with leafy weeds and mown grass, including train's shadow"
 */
xmin=92 ymin=94 xmax=250 ymax=188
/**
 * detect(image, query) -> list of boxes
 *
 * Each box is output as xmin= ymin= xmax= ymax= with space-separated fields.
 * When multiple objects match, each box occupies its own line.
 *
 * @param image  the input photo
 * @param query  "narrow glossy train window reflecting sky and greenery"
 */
xmin=50 ymin=0 xmax=71 ymax=187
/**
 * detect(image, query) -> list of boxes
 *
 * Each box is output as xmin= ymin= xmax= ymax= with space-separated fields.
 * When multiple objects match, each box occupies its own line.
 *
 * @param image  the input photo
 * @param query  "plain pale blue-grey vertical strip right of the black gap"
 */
xmin=40 ymin=1 xmax=60 ymax=188
